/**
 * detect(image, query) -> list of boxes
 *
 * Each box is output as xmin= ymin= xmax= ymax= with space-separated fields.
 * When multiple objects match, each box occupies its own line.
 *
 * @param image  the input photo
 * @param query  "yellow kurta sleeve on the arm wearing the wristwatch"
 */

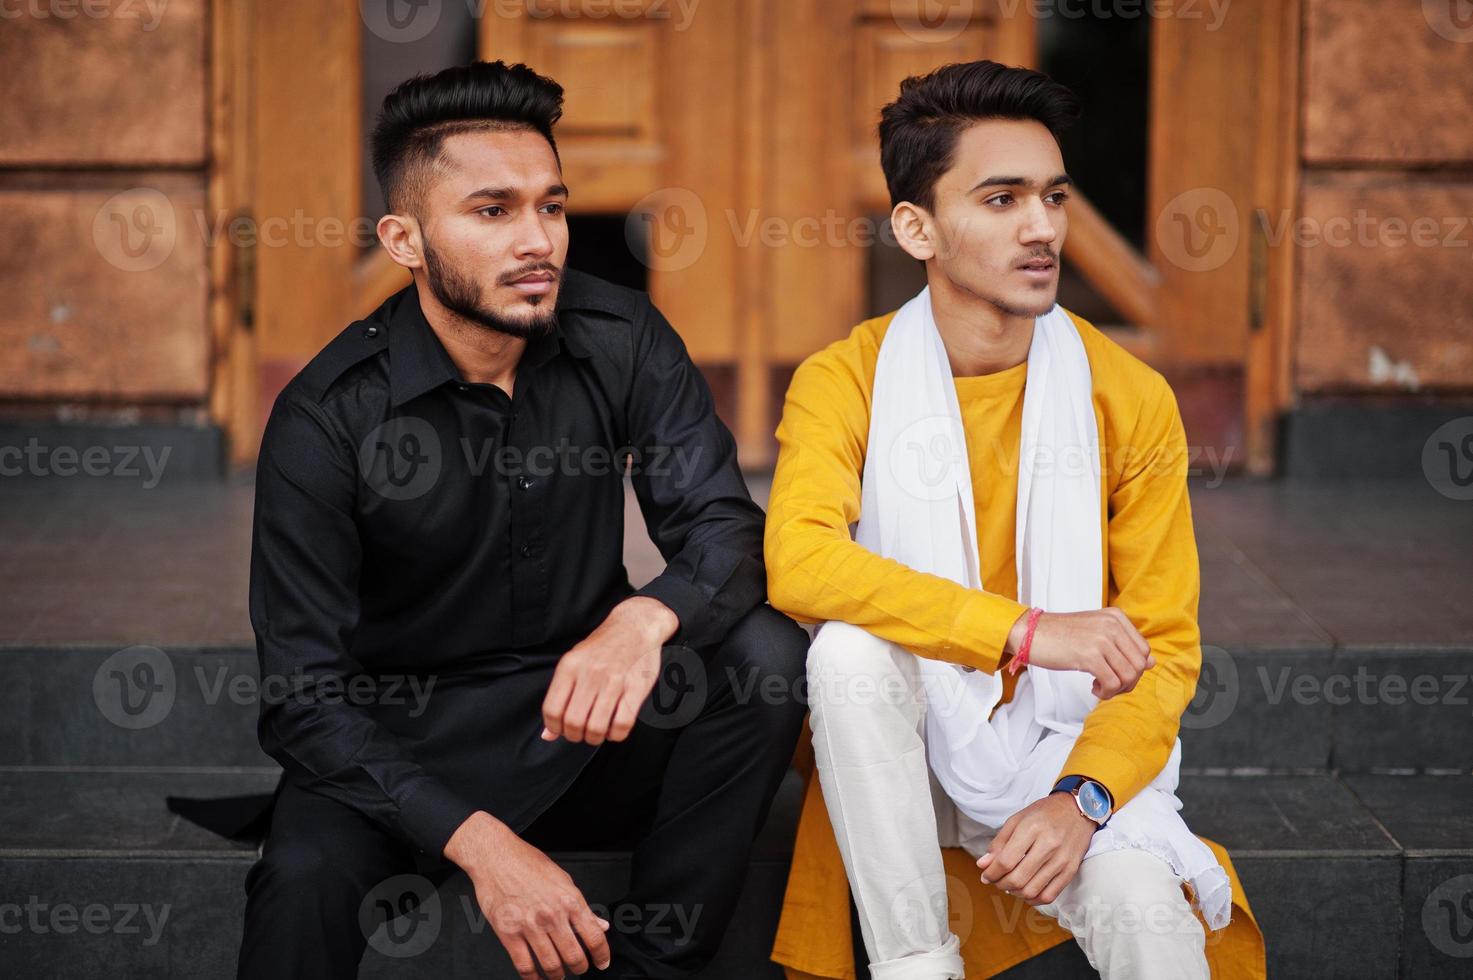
xmin=1059 ymin=374 xmax=1202 ymax=808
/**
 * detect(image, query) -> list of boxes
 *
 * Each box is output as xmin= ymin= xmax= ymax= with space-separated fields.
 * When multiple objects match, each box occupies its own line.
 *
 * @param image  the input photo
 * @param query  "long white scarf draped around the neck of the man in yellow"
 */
xmin=856 ymin=289 xmax=1231 ymax=928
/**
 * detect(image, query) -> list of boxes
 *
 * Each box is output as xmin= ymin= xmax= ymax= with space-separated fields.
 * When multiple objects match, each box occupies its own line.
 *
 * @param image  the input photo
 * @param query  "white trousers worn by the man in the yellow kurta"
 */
xmin=807 ymin=626 xmax=1209 ymax=980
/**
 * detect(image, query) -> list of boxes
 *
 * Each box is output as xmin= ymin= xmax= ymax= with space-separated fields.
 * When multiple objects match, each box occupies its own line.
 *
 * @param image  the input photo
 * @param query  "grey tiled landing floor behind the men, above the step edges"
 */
xmin=0 ymin=476 xmax=1473 ymax=651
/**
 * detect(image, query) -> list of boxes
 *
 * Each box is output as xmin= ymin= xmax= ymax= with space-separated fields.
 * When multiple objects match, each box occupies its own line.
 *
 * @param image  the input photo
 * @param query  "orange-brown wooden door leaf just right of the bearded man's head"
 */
xmin=482 ymin=0 xmax=744 ymax=363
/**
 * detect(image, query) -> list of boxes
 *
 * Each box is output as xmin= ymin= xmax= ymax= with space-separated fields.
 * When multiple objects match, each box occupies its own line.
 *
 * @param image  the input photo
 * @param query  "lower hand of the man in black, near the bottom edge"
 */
xmin=445 ymin=807 xmax=612 ymax=980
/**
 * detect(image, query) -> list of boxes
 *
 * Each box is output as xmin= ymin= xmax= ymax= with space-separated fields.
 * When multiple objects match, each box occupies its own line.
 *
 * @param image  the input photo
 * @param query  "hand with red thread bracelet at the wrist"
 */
xmin=1006 ymin=606 xmax=1156 ymax=701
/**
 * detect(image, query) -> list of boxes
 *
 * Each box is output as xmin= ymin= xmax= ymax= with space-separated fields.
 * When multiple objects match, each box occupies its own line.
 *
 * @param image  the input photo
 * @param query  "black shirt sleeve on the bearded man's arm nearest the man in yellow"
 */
xmin=627 ymin=301 xmax=766 ymax=648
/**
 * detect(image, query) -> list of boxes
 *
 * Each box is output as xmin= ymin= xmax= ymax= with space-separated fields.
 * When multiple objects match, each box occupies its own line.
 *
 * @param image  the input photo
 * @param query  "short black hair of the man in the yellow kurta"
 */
xmin=879 ymin=60 xmax=1080 ymax=211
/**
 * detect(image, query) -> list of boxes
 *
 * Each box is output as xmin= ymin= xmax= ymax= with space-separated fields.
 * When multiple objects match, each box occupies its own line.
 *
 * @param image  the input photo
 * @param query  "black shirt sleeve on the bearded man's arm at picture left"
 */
xmin=250 ymin=389 xmax=476 ymax=855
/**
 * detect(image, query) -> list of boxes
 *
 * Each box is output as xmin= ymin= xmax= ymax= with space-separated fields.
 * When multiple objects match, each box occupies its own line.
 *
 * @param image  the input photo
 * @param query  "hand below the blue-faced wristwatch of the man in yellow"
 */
xmin=977 ymin=793 xmax=1097 ymax=905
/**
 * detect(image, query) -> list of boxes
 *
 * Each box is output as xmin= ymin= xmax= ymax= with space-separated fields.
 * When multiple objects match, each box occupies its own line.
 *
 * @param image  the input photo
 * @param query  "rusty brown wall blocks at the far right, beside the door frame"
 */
xmin=1302 ymin=0 xmax=1473 ymax=393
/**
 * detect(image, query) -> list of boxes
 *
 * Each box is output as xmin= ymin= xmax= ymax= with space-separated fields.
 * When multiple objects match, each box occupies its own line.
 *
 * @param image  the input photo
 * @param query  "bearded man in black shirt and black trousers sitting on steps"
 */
xmin=240 ymin=62 xmax=807 ymax=980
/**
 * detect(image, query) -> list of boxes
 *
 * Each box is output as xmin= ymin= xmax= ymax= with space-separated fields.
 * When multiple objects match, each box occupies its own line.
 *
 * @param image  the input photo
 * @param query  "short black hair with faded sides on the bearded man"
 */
xmin=373 ymin=62 xmax=563 ymax=211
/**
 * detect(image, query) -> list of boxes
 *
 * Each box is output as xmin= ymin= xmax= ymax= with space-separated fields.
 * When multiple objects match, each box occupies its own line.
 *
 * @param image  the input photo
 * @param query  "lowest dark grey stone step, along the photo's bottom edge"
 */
xmin=0 ymin=768 xmax=1473 ymax=980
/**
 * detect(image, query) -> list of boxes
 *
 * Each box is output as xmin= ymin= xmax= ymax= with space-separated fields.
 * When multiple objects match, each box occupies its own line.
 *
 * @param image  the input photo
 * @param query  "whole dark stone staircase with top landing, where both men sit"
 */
xmin=0 ymin=471 xmax=1473 ymax=980
